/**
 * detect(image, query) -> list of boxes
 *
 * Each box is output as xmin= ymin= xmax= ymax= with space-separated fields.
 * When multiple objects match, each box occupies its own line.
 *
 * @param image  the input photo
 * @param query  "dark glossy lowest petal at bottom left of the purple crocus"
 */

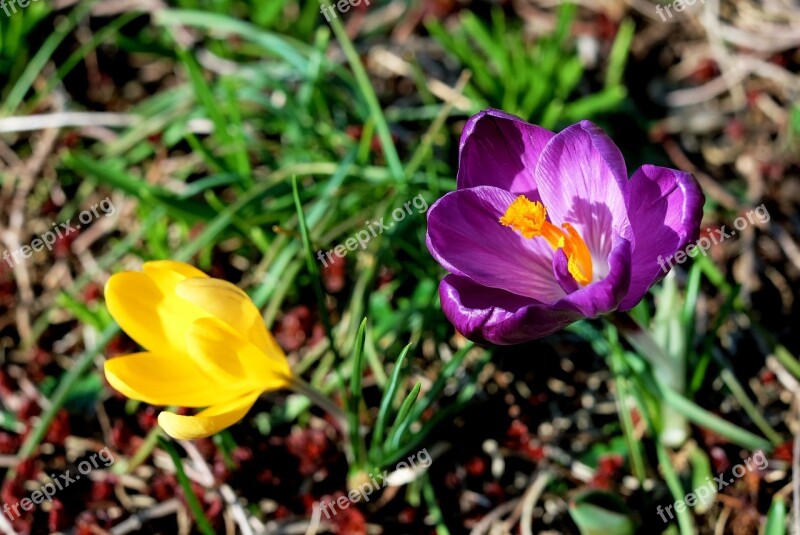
xmin=439 ymin=275 xmax=581 ymax=345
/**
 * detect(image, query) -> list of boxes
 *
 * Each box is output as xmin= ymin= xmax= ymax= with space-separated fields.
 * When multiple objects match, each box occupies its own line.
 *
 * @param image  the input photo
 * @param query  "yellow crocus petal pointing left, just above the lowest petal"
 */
xmin=104 ymin=353 xmax=242 ymax=407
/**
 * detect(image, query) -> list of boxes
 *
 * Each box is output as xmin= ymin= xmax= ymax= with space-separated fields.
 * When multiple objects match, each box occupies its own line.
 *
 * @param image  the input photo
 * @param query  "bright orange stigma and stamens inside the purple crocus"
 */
xmin=500 ymin=195 xmax=592 ymax=286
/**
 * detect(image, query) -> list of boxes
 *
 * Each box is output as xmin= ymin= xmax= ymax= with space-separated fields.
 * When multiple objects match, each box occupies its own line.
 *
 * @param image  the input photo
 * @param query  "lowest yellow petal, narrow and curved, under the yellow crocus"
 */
xmin=158 ymin=392 xmax=261 ymax=440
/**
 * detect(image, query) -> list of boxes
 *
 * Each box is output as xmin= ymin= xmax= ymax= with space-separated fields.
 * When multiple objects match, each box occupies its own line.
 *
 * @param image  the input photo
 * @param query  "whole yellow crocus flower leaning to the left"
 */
xmin=105 ymin=261 xmax=293 ymax=440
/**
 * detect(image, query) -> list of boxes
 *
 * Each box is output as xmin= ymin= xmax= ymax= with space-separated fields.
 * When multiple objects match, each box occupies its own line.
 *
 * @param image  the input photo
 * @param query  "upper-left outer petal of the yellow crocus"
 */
xmin=105 ymin=270 xmax=206 ymax=358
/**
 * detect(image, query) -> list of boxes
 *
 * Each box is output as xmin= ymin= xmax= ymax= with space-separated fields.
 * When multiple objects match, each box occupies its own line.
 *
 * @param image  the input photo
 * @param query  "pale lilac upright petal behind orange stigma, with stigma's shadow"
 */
xmin=536 ymin=121 xmax=632 ymax=264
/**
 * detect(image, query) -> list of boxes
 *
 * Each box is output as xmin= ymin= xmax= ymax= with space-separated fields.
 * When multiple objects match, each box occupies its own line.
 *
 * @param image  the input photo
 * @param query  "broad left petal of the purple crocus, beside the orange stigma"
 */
xmin=426 ymin=186 xmax=564 ymax=303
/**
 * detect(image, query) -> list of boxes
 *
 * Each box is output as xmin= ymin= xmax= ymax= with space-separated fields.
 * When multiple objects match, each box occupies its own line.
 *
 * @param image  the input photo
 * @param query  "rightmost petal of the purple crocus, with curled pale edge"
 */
xmin=620 ymin=165 xmax=705 ymax=310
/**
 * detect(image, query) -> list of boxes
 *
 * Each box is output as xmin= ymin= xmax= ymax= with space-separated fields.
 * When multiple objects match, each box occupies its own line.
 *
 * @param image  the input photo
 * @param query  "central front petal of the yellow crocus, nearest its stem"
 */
xmin=186 ymin=317 xmax=292 ymax=391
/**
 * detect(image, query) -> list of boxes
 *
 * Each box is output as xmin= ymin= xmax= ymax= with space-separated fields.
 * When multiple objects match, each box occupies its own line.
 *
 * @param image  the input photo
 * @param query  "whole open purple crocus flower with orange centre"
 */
xmin=427 ymin=109 xmax=704 ymax=344
